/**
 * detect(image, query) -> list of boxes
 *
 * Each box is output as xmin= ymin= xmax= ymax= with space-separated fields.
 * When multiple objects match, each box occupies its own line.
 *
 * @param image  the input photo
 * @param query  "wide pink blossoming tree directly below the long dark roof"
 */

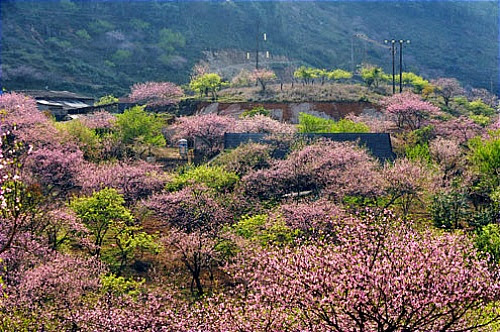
xmin=242 ymin=140 xmax=380 ymax=199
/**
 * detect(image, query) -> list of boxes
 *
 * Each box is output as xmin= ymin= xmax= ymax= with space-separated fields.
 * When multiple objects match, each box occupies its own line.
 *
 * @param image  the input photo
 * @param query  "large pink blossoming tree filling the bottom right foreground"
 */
xmin=214 ymin=212 xmax=500 ymax=331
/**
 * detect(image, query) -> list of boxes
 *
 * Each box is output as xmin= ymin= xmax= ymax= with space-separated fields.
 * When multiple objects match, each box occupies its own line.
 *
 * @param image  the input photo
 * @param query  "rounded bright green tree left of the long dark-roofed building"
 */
xmin=116 ymin=106 xmax=166 ymax=146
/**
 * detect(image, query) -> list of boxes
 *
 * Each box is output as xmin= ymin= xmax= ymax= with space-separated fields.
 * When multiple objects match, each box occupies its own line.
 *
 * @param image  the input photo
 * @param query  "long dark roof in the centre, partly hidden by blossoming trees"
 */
xmin=224 ymin=133 xmax=395 ymax=161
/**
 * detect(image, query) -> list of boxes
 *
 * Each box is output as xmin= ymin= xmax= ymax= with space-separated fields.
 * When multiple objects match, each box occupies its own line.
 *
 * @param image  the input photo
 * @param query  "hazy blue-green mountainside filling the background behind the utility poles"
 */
xmin=1 ymin=0 xmax=498 ymax=96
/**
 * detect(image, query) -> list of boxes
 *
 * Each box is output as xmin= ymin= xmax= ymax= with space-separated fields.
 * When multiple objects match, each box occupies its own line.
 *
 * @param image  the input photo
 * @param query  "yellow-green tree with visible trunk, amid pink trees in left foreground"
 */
xmin=70 ymin=188 xmax=134 ymax=257
